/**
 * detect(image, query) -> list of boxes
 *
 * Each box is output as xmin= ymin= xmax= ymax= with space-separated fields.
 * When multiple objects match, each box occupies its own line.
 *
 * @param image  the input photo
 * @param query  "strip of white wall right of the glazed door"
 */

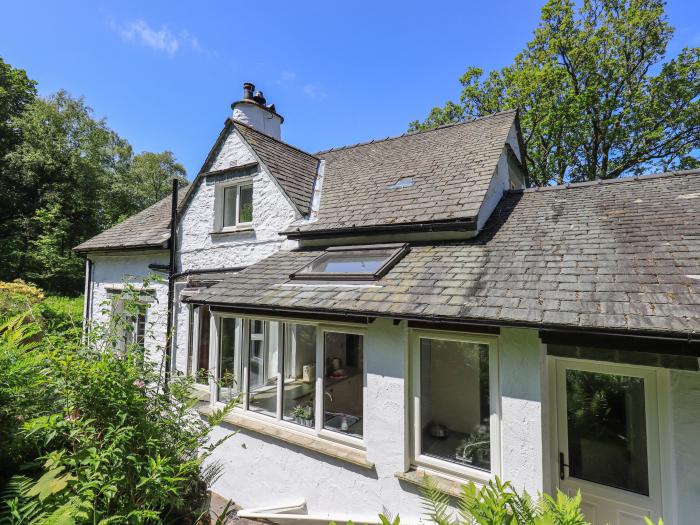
xmin=662 ymin=371 xmax=700 ymax=525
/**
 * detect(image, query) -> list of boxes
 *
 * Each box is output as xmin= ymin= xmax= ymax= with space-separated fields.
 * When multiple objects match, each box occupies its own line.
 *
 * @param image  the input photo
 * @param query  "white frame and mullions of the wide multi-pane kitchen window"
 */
xmin=209 ymin=311 xmax=367 ymax=450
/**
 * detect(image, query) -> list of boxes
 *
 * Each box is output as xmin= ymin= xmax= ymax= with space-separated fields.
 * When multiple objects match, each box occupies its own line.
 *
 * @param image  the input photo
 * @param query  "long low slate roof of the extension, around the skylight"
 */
xmin=185 ymin=171 xmax=700 ymax=334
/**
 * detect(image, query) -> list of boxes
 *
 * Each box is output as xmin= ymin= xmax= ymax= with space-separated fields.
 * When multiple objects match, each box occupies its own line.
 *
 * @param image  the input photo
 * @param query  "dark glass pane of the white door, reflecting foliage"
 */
xmin=566 ymin=370 xmax=649 ymax=495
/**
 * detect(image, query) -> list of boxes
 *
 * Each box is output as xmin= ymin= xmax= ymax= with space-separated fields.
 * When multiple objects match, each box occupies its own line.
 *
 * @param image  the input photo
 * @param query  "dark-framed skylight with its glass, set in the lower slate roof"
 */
xmin=289 ymin=244 xmax=408 ymax=281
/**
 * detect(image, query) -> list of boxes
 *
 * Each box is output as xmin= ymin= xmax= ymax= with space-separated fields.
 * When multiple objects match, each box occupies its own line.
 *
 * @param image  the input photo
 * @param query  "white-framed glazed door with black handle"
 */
xmin=556 ymin=360 xmax=660 ymax=525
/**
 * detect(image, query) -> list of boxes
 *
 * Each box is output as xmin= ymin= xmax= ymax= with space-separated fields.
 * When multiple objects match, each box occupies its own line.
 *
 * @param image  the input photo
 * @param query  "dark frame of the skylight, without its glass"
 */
xmin=289 ymin=243 xmax=410 ymax=281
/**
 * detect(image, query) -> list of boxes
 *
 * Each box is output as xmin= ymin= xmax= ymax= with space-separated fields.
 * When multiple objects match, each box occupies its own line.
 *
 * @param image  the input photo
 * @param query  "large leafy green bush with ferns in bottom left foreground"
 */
xmin=0 ymin=287 xmax=237 ymax=524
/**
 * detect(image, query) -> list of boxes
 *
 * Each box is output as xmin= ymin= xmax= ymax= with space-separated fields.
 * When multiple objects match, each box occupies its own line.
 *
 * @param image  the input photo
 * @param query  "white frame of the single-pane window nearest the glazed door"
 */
xmin=407 ymin=329 xmax=501 ymax=484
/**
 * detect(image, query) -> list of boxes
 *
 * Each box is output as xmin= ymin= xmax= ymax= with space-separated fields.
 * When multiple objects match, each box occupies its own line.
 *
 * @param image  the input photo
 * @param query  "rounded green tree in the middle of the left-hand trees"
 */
xmin=0 ymin=91 xmax=131 ymax=292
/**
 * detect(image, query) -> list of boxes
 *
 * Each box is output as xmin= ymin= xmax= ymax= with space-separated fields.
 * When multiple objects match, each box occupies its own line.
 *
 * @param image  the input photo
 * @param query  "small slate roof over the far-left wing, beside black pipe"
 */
xmin=73 ymin=186 xmax=189 ymax=252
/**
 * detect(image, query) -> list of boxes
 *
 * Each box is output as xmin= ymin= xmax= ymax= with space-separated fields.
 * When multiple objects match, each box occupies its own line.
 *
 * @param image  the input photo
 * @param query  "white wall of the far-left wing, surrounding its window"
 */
xmin=89 ymin=250 xmax=168 ymax=353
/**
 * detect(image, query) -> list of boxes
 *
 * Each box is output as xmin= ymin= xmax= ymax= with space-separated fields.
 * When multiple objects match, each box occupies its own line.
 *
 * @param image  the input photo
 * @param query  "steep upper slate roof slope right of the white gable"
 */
xmin=288 ymin=111 xmax=517 ymax=232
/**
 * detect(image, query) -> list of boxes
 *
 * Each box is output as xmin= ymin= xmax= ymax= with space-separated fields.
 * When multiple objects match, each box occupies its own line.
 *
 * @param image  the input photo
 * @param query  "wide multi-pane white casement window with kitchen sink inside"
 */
xmin=212 ymin=314 xmax=365 ymax=444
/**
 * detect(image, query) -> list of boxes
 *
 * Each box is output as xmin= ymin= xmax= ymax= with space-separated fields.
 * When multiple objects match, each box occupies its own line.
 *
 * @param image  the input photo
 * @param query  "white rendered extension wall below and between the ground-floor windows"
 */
xmin=202 ymin=319 xmax=543 ymax=523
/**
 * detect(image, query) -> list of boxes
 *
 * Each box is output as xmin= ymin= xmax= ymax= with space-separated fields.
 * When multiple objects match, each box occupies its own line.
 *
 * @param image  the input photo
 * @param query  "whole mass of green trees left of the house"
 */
xmin=0 ymin=59 xmax=186 ymax=293
